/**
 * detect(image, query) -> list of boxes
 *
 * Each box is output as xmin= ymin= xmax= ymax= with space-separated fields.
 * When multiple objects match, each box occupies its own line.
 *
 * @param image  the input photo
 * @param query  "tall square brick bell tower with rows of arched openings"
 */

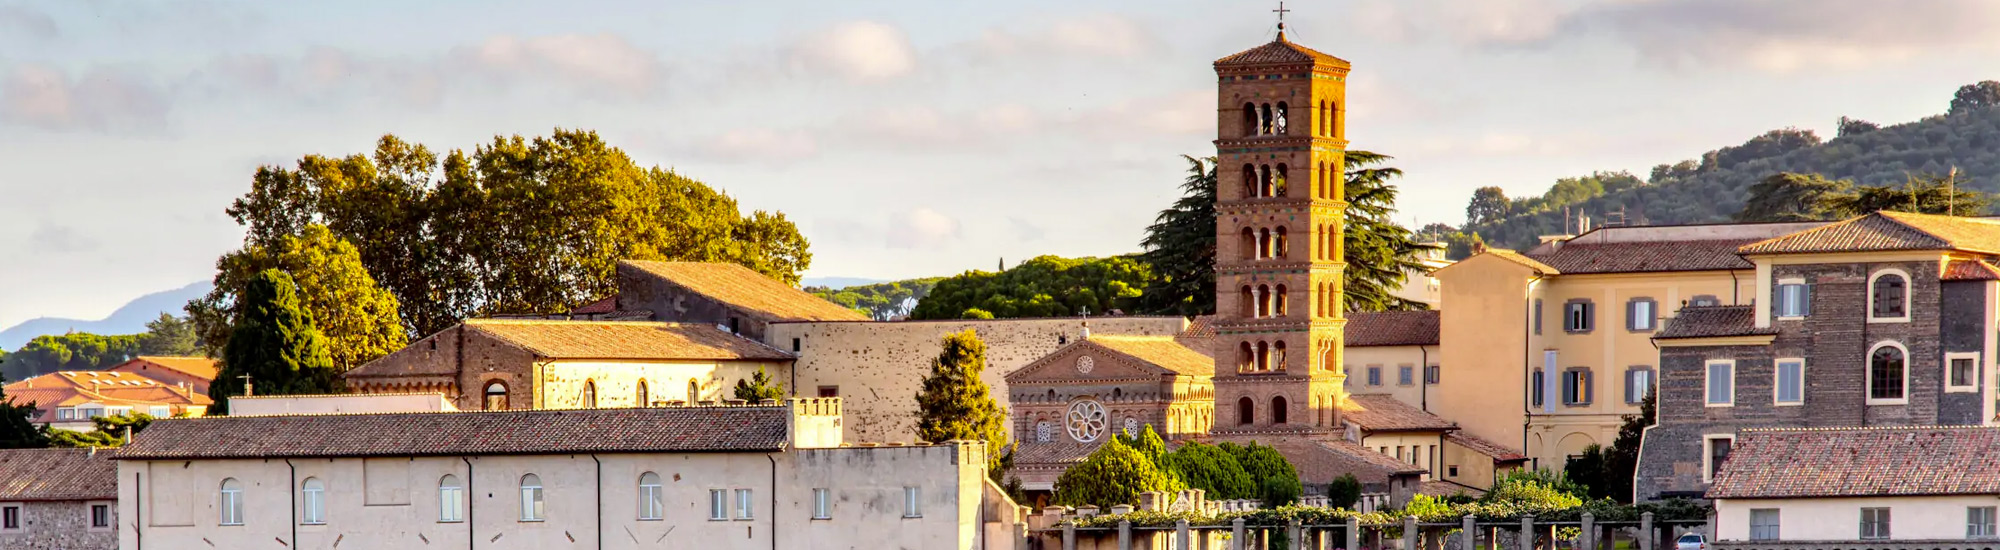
xmin=1212 ymin=23 xmax=1348 ymax=438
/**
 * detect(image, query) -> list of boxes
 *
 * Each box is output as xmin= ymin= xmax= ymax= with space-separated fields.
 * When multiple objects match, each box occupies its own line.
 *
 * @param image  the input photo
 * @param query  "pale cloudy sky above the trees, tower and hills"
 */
xmin=0 ymin=0 xmax=2000 ymax=326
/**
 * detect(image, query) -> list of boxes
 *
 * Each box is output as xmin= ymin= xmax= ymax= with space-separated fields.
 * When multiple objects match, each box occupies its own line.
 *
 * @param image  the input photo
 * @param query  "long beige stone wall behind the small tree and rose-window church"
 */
xmin=764 ymin=316 xmax=1188 ymax=442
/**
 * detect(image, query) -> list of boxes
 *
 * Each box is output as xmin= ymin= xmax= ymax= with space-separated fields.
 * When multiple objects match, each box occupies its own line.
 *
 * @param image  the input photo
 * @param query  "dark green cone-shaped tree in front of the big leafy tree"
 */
xmin=208 ymin=270 xmax=340 ymax=414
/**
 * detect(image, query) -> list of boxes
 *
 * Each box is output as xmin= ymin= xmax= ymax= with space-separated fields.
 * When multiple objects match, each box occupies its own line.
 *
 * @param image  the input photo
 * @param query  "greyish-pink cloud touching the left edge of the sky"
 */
xmin=0 ymin=64 xmax=168 ymax=132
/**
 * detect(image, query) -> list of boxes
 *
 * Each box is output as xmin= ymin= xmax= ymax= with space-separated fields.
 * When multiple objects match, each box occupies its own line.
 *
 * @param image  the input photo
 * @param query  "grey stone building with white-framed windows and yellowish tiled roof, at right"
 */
xmin=1634 ymin=212 xmax=2000 ymax=500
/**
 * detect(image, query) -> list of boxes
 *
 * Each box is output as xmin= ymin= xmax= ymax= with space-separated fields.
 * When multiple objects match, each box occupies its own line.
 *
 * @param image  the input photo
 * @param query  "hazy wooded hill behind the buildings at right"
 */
xmin=1460 ymin=84 xmax=2000 ymax=248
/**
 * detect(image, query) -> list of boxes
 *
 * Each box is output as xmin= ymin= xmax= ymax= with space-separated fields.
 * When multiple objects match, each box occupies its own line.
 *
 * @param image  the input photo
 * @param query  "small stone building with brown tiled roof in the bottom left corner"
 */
xmin=0 ymin=448 xmax=120 ymax=550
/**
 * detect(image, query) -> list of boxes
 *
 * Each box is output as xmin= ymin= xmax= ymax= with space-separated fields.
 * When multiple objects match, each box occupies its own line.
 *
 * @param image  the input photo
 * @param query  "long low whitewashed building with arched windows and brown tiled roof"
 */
xmin=118 ymin=400 xmax=1026 ymax=550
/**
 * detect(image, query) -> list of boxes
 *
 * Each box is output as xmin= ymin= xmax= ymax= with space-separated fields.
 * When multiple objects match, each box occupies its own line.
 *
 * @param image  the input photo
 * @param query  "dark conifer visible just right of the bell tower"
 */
xmin=1342 ymin=150 xmax=1436 ymax=312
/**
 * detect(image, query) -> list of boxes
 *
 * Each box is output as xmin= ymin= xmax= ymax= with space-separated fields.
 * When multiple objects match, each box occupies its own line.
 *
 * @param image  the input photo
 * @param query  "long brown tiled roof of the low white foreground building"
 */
xmin=118 ymin=406 xmax=788 ymax=460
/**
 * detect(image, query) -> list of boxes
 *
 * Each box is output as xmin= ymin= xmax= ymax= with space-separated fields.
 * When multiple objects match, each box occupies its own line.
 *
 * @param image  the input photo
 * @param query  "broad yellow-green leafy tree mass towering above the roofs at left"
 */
xmin=228 ymin=130 xmax=812 ymax=334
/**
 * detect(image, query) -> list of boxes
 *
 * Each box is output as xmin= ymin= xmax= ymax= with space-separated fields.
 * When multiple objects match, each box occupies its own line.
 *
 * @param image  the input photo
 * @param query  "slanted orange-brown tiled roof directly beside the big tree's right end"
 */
xmin=620 ymin=260 xmax=868 ymax=320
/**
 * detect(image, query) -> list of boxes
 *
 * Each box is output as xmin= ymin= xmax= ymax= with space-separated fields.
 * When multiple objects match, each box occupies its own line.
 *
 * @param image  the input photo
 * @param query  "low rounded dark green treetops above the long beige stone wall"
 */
xmin=910 ymin=256 xmax=1152 ymax=318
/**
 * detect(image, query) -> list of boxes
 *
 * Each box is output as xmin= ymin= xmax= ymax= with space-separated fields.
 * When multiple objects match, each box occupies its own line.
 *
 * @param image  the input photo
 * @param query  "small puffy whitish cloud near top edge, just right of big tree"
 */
xmin=786 ymin=20 xmax=916 ymax=82
